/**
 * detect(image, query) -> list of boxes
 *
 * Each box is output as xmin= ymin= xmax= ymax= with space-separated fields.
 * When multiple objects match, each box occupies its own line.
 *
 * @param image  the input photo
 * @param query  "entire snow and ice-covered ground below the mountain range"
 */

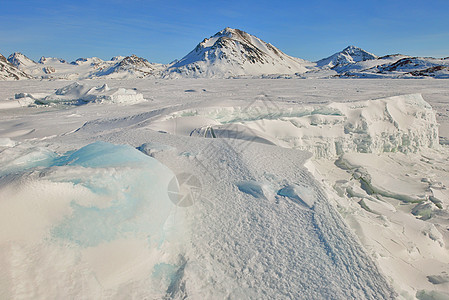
xmin=0 ymin=79 xmax=449 ymax=299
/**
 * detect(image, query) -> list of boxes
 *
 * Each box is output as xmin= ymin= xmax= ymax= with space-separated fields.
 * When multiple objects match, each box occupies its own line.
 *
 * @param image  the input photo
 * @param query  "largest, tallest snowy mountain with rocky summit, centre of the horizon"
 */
xmin=165 ymin=27 xmax=312 ymax=78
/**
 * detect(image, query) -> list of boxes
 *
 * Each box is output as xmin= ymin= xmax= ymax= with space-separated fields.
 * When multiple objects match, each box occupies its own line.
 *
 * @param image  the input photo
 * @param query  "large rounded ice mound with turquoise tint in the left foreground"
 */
xmin=0 ymin=142 xmax=182 ymax=298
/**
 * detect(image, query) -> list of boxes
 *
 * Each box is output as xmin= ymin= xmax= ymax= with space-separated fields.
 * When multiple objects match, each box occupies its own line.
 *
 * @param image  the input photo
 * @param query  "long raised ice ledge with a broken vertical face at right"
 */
xmin=152 ymin=94 xmax=439 ymax=158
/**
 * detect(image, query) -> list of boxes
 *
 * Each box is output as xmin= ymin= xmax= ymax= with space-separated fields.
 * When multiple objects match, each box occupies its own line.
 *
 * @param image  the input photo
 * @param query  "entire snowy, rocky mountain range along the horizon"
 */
xmin=0 ymin=27 xmax=449 ymax=80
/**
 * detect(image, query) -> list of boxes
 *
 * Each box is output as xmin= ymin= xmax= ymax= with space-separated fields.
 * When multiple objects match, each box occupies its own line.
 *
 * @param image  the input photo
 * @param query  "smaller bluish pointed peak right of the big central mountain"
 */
xmin=317 ymin=46 xmax=377 ymax=69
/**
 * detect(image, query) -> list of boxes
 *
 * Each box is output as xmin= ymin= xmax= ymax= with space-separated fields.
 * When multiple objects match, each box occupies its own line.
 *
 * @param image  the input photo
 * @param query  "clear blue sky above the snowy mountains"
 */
xmin=0 ymin=0 xmax=449 ymax=63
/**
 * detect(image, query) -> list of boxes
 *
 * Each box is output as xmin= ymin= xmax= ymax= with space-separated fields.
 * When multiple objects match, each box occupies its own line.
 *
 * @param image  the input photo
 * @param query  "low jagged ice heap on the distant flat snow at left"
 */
xmin=14 ymin=82 xmax=145 ymax=106
